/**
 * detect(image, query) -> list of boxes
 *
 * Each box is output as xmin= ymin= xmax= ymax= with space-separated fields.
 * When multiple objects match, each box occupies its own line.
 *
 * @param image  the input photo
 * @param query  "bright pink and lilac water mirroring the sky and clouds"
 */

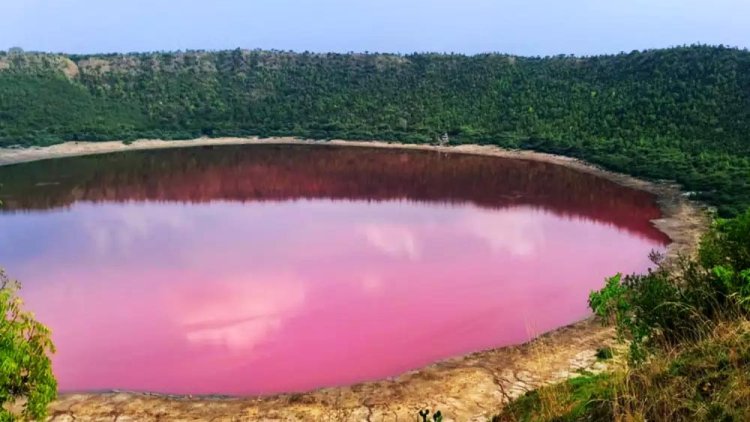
xmin=0 ymin=200 xmax=658 ymax=394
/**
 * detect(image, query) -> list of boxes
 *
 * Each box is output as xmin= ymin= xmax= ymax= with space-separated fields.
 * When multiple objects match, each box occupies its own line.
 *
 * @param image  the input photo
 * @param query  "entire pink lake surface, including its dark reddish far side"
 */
xmin=0 ymin=146 xmax=669 ymax=394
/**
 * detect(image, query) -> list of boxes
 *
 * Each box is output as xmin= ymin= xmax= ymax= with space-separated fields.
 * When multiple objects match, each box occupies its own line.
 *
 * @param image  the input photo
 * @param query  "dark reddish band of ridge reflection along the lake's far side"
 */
xmin=0 ymin=146 xmax=665 ymax=241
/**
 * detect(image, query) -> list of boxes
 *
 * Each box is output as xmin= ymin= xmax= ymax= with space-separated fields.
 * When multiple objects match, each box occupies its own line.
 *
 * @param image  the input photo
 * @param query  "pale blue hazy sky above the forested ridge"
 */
xmin=0 ymin=0 xmax=750 ymax=55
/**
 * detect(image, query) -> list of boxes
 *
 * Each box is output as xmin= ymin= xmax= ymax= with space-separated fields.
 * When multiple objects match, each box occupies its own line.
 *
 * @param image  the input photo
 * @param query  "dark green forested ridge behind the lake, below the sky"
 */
xmin=0 ymin=46 xmax=750 ymax=215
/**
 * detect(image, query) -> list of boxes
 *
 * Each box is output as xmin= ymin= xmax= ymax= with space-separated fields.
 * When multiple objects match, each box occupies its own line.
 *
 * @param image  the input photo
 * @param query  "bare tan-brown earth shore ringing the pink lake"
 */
xmin=0 ymin=138 xmax=709 ymax=421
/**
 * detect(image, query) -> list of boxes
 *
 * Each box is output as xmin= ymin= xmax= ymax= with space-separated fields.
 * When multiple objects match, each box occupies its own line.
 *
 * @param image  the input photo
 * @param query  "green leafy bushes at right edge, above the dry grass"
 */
xmin=589 ymin=210 xmax=750 ymax=363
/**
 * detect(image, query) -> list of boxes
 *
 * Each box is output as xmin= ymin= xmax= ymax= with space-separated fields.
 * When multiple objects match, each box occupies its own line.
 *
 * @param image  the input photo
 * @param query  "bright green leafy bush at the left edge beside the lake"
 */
xmin=0 ymin=270 xmax=57 ymax=421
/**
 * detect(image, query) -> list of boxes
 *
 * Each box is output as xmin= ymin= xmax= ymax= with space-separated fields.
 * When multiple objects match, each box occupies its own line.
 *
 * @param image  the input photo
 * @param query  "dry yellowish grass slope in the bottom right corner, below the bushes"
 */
xmin=494 ymin=318 xmax=750 ymax=422
